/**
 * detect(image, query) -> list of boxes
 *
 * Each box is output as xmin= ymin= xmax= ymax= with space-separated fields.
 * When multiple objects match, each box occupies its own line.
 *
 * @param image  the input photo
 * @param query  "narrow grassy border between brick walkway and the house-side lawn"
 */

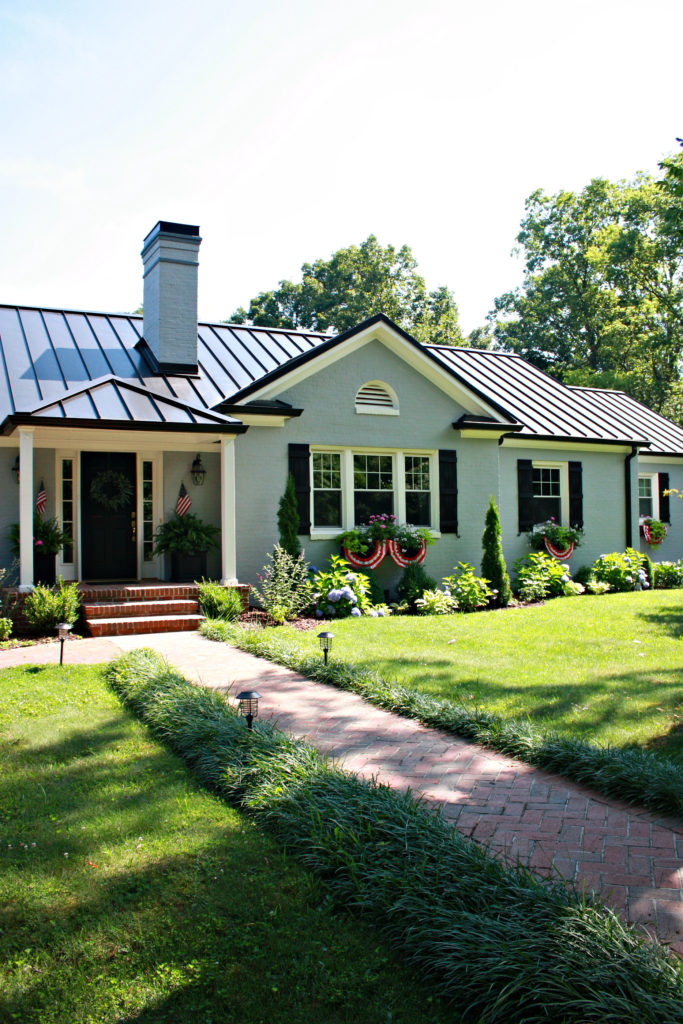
xmin=201 ymin=622 xmax=683 ymax=817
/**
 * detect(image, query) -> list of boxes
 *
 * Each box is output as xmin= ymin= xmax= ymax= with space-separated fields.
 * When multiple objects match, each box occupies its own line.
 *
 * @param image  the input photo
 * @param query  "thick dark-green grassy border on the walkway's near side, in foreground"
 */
xmin=106 ymin=649 xmax=683 ymax=1024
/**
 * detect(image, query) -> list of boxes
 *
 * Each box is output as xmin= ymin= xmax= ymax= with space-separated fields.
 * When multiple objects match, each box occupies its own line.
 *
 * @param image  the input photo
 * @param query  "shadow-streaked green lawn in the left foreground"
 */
xmin=0 ymin=666 xmax=454 ymax=1024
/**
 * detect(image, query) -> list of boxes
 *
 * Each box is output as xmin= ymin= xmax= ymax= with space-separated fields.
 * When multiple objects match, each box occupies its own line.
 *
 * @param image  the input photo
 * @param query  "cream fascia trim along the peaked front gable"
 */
xmin=240 ymin=324 xmax=501 ymax=419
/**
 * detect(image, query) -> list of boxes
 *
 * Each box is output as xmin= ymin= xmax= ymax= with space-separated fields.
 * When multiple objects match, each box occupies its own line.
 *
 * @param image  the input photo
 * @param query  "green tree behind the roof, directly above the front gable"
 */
xmin=230 ymin=234 xmax=463 ymax=345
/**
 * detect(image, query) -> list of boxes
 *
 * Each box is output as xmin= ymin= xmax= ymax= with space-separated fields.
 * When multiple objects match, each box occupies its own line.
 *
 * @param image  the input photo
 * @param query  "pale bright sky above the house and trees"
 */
xmin=0 ymin=0 xmax=683 ymax=330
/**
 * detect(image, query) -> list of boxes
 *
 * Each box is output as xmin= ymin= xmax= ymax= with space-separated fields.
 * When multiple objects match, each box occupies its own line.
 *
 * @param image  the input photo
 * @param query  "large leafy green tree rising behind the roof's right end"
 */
xmin=489 ymin=158 xmax=683 ymax=409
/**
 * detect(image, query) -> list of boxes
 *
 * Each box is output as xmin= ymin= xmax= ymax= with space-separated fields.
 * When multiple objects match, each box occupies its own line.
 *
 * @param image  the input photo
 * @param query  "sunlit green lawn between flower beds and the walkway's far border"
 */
xmin=272 ymin=591 xmax=683 ymax=757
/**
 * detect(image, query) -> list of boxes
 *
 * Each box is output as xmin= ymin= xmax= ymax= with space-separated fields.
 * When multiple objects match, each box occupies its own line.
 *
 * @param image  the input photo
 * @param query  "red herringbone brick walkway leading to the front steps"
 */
xmin=0 ymin=633 xmax=683 ymax=955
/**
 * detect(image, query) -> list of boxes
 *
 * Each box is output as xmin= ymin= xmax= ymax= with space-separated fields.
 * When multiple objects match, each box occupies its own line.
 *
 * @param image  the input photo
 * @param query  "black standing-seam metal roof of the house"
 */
xmin=0 ymin=306 xmax=683 ymax=455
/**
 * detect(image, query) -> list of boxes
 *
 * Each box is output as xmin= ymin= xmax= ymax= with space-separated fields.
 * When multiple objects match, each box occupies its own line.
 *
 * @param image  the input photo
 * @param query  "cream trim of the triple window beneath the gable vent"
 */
xmin=309 ymin=444 xmax=441 ymax=541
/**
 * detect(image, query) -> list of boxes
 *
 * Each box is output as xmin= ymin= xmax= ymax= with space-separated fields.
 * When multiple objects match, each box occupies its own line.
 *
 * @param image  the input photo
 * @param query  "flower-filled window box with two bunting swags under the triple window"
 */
xmin=337 ymin=514 xmax=434 ymax=569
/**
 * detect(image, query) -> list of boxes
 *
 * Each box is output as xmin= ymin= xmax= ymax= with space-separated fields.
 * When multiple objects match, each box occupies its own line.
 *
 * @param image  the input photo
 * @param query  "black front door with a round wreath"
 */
xmin=81 ymin=452 xmax=137 ymax=580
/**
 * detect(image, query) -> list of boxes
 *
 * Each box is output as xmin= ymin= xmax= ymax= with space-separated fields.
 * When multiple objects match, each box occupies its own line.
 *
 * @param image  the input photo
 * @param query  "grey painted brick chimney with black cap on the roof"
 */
xmin=141 ymin=220 xmax=202 ymax=374
